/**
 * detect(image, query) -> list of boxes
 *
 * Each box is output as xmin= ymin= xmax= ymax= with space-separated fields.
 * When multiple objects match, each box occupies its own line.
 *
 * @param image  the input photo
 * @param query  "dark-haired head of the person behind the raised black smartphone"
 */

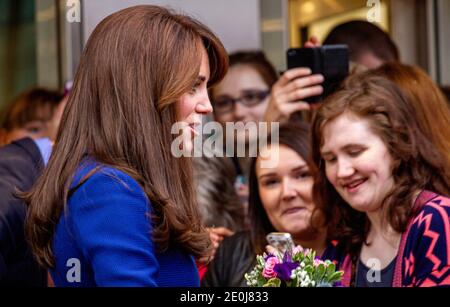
xmin=322 ymin=20 xmax=400 ymax=69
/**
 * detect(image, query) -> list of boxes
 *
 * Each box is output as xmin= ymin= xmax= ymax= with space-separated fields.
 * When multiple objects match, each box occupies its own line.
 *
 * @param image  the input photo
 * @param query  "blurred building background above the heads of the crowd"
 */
xmin=0 ymin=0 xmax=450 ymax=108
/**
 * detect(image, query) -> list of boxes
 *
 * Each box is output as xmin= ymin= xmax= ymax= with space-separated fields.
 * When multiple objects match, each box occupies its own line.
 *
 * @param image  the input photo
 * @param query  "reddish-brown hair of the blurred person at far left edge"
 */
xmin=0 ymin=87 xmax=63 ymax=145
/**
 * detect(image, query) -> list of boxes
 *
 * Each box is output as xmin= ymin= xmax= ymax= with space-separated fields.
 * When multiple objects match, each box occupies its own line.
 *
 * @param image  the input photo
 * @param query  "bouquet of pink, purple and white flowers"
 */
xmin=245 ymin=246 xmax=344 ymax=287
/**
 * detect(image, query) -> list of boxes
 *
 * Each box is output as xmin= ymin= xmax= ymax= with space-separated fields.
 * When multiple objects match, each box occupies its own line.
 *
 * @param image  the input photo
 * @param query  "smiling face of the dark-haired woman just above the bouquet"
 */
xmin=256 ymin=145 xmax=315 ymax=239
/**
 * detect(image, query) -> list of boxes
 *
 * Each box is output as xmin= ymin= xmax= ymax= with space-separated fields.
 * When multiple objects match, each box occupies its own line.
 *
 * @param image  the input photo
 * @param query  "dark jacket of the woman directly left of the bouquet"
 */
xmin=202 ymin=231 xmax=256 ymax=287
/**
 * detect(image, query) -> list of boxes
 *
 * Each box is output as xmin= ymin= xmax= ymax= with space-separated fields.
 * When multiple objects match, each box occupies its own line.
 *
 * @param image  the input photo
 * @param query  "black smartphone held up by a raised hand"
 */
xmin=286 ymin=45 xmax=349 ymax=103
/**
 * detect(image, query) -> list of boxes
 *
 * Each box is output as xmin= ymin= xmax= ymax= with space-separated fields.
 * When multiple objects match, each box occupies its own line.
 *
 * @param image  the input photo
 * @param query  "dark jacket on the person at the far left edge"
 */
xmin=0 ymin=139 xmax=46 ymax=286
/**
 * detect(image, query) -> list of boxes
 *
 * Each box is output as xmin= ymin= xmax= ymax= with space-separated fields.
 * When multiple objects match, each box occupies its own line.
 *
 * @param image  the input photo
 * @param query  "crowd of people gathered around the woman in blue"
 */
xmin=0 ymin=5 xmax=450 ymax=287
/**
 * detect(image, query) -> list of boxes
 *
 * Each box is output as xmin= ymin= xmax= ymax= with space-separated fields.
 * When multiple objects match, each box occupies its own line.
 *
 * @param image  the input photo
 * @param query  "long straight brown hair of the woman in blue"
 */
xmin=26 ymin=5 xmax=227 ymax=267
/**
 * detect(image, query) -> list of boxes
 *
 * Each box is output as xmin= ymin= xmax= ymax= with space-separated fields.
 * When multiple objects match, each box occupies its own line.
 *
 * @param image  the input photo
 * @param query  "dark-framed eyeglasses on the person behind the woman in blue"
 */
xmin=213 ymin=90 xmax=270 ymax=114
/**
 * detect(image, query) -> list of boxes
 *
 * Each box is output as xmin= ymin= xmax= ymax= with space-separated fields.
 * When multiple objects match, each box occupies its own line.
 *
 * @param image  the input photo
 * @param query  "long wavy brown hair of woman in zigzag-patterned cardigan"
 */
xmin=312 ymin=71 xmax=450 ymax=256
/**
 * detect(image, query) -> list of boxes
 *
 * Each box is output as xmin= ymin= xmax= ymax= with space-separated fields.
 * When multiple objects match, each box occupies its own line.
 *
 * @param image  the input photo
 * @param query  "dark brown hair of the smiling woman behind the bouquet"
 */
xmin=248 ymin=122 xmax=316 ymax=254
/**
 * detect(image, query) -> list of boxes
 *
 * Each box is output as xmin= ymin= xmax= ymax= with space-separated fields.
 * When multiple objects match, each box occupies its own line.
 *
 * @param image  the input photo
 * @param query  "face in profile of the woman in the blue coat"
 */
xmin=176 ymin=47 xmax=212 ymax=150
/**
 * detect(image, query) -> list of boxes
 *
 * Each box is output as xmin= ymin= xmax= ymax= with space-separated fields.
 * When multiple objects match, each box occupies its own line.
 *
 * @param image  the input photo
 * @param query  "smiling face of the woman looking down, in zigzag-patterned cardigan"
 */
xmin=321 ymin=112 xmax=394 ymax=212
